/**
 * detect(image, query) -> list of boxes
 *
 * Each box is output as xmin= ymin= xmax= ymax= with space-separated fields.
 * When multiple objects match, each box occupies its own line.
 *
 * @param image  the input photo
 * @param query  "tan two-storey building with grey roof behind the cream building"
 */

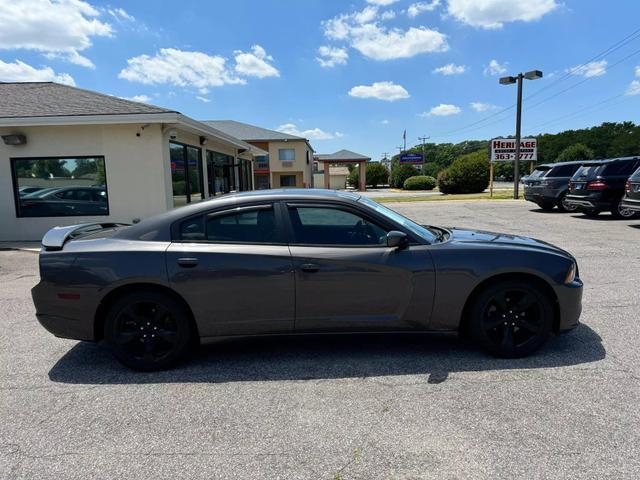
xmin=204 ymin=120 xmax=313 ymax=189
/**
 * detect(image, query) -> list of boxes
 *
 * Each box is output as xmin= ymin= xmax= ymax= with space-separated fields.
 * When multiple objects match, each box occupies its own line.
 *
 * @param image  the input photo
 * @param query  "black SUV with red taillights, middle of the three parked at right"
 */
xmin=566 ymin=157 xmax=640 ymax=218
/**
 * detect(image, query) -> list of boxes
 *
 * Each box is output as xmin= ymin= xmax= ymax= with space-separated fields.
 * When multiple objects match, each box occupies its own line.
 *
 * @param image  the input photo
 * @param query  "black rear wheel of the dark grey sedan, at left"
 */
xmin=104 ymin=291 xmax=195 ymax=372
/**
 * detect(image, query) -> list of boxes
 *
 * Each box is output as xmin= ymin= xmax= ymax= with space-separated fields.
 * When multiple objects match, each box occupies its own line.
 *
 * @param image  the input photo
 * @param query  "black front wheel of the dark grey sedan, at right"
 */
xmin=469 ymin=280 xmax=554 ymax=358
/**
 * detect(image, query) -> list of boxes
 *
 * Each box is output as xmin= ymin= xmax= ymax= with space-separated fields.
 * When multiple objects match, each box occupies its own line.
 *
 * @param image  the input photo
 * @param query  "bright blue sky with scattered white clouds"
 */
xmin=0 ymin=0 xmax=640 ymax=159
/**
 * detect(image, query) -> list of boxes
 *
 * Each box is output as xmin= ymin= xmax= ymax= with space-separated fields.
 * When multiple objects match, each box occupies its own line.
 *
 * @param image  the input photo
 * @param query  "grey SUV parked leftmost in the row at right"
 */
xmin=522 ymin=161 xmax=583 ymax=212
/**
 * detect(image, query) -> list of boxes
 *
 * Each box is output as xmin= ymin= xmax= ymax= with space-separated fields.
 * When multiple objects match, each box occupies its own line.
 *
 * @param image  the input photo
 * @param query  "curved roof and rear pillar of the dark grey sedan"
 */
xmin=114 ymin=188 xmax=360 ymax=241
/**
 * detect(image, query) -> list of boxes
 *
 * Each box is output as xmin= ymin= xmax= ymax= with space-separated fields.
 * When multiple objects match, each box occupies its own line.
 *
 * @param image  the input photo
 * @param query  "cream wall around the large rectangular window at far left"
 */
xmin=0 ymin=125 xmax=172 ymax=240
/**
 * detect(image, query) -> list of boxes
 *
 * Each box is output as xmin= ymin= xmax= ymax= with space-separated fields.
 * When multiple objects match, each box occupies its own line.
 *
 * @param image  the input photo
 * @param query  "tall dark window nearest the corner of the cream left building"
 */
xmin=169 ymin=142 xmax=204 ymax=207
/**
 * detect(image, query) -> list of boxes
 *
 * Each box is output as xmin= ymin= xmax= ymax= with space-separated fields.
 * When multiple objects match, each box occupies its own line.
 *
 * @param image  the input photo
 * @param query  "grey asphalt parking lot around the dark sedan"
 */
xmin=0 ymin=201 xmax=640 ymax=479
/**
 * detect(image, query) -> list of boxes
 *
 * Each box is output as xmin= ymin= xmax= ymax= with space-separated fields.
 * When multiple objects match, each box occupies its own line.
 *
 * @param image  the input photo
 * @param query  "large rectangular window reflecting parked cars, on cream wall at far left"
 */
xmin=11 ymin=157 xmax=109 ymax=217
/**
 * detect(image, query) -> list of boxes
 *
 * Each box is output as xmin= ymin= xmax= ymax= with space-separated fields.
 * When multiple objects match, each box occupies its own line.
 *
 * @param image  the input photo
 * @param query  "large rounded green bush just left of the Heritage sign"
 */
xmin=438 ymin=150 xmax=489 ymax=193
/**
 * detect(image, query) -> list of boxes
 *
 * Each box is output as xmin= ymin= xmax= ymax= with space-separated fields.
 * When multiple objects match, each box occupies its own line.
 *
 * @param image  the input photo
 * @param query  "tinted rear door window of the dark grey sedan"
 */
xmin=206 ymin=209 xmax=277 ymax=243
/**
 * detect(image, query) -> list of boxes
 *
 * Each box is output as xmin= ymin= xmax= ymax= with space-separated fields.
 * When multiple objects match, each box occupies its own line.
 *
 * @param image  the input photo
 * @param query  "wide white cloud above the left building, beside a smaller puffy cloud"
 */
xmin=118 ymin=48 xmax=246 ymax=88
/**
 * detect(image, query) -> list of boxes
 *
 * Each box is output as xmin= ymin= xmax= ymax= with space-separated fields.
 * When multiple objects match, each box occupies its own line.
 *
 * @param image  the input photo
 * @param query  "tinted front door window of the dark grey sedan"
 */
xmin=289 ymin=207 xmax=387 ymax=246
